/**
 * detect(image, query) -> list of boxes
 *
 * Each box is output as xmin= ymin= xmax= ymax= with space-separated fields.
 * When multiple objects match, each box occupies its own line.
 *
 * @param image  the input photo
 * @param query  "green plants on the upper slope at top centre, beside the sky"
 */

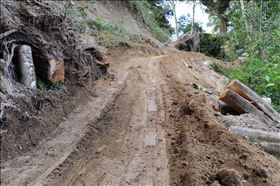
xmin=126 ymin=0 xmax=171 ymax=42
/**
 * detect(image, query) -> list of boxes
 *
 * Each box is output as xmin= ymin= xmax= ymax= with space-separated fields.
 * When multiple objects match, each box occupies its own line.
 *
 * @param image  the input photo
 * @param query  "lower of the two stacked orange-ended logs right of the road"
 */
xmin=220 ymin=90 xmax=273 ymax=124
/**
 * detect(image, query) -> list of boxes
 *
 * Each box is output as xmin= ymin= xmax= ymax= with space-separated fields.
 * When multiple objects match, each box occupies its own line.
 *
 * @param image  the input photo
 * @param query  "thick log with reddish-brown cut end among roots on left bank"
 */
xmin=35 ymin=58 xmax=65 ymax=83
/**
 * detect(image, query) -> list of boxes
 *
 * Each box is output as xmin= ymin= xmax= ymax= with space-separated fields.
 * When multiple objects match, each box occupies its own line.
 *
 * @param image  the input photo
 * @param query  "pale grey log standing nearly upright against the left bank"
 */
xmin=18 ymin=45 xmax=37 ymax=89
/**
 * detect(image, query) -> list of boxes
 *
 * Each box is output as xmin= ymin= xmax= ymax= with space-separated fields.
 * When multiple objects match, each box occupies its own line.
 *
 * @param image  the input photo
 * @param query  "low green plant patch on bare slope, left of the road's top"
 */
xmin=88 ymin=17 xmax=131 ymax=48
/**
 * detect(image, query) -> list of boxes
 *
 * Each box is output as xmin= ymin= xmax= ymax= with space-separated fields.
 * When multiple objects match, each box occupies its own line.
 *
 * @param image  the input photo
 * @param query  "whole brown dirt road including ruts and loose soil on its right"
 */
xmin=1 ymin=47 xmax=280 ymax=186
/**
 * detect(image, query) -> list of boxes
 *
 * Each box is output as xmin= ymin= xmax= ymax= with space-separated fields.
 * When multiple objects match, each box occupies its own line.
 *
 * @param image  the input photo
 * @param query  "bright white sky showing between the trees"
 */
xmin=169 ymin=1 xmax=212 ymax=39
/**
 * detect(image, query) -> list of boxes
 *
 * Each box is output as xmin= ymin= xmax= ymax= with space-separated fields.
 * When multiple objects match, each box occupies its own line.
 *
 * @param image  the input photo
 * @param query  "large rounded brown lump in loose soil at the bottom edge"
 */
xmin=216 ymin=169 xmax=243 ymax=186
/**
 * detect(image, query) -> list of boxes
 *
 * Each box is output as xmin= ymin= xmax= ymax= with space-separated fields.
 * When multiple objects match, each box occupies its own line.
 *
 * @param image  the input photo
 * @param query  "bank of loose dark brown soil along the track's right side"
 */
xmin=160 ymin=53 xmax=280 ymax=185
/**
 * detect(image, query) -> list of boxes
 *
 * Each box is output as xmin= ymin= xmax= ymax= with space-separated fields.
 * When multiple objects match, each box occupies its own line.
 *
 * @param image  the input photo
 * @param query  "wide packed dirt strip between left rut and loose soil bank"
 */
xmin=19 ymin=56 xmax=169 ymax=185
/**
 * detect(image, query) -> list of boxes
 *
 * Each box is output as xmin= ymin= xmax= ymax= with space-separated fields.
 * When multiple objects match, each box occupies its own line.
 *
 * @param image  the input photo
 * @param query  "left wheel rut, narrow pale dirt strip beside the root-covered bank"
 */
xmin=1 ymin=77 xmax=125 ymax=186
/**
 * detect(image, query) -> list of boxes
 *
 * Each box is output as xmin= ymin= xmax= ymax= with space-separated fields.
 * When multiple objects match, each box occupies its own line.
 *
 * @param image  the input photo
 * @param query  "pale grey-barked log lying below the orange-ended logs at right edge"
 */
xmin=229 ymin=126 xmax=280 ymax=154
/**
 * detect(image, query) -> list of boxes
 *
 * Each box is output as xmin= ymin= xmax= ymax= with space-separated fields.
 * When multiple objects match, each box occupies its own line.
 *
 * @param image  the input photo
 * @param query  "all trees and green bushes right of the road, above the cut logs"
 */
xmin=174 ymin=0 xmax=280 ymax=112
